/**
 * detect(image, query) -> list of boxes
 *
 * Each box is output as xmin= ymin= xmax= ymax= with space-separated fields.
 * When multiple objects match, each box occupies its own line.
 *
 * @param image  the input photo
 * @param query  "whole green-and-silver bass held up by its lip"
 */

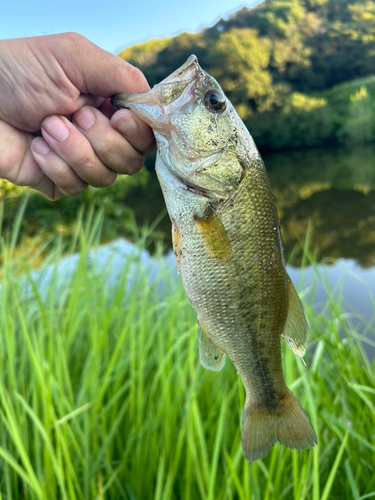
xmin=111 ymin=55 xmax=317 ymax=462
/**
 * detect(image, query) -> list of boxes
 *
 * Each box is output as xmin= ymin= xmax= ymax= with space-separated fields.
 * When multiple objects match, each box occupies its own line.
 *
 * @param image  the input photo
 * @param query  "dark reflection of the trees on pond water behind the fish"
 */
xmin=131 ymin=145 xmax=375 ymax=267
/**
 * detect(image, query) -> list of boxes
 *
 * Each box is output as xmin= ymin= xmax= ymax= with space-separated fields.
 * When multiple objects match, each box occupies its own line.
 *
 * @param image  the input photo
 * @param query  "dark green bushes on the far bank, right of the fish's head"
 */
xmin=245 ymin=77 xmax=375 ymax=150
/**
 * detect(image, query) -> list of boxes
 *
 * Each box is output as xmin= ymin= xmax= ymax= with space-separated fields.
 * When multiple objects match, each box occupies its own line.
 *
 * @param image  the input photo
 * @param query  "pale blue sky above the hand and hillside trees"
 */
xmin=0 ymin=0 xmax=259 ymax=54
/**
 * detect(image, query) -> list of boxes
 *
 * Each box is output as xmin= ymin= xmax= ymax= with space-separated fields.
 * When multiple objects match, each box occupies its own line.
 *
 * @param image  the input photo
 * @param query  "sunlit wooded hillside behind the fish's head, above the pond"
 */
xmin=120 ymin=0 xmax=375 ymax=150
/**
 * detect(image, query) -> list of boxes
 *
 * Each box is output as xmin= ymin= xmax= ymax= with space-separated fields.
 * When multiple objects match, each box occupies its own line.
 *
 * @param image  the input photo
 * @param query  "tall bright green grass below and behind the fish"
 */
xmin=0 ymin=204 xmax=375 ymax=500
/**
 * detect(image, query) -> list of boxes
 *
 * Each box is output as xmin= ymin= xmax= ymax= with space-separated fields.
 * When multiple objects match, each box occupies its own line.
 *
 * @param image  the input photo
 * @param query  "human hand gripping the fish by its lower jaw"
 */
xmin=0 ymin=33 xmax=155 ymax=200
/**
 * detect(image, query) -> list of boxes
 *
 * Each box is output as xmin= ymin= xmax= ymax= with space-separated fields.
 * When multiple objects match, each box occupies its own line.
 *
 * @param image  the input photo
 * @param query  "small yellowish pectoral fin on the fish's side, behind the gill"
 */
xmin=195 ymin=208 xmax=232 ymax=260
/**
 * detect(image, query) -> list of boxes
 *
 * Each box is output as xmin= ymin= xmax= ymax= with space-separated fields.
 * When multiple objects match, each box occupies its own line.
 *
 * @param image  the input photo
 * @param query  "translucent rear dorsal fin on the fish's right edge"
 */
xmin=281 ymin=276 xmax=309 ymax=358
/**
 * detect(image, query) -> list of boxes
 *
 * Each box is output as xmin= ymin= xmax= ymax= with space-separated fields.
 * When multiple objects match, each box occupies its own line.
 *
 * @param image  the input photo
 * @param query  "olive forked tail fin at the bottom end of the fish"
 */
xmin=242 ymin=389 xmax=318 ymax=462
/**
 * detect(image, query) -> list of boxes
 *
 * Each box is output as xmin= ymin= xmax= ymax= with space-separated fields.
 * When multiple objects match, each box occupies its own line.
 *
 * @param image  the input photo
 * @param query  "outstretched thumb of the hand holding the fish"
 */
xmin=49 ymin=33 xmax=150 ymax=97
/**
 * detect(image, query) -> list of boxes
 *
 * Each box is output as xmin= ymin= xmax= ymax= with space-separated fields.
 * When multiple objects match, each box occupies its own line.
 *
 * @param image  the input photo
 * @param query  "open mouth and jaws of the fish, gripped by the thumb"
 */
xmin=111 ymin=55 xmax=203 ymax=133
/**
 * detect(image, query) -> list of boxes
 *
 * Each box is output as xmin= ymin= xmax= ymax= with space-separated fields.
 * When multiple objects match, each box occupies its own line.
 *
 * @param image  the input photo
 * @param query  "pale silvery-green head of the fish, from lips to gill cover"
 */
xmin=112 ymin=56 xmax=256 ymax=197
